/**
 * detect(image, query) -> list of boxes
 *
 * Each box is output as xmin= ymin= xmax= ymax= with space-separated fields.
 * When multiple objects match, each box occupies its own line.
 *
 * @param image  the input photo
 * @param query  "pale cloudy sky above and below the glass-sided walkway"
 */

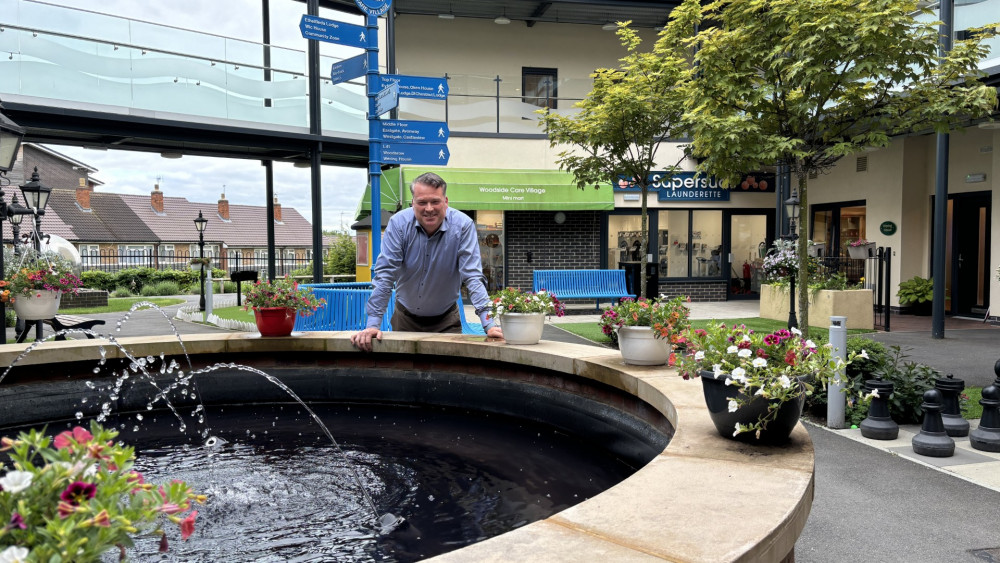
xmin=36 ymin=0 xmax=367 ymax=230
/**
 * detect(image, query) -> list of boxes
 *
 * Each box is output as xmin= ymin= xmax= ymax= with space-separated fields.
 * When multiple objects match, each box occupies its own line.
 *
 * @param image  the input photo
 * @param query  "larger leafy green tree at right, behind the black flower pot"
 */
xmin=680 ymin=0 xmax=996 ymax=332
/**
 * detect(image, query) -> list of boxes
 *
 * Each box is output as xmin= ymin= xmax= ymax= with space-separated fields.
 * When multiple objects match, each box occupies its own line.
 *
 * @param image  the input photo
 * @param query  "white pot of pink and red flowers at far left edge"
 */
xmin=0 ymin=255 xmax=83 ymax=321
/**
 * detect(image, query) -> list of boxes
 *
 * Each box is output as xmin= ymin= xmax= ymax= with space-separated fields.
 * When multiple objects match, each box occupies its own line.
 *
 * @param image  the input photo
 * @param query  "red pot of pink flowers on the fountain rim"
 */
xmin=243 ymin=276 xmax=326 ymax=336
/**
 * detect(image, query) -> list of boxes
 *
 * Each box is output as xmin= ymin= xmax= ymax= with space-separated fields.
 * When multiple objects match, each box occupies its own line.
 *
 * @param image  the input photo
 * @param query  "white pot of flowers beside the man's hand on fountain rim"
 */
xmin=490 ymin=287 xmax=566 ymax=344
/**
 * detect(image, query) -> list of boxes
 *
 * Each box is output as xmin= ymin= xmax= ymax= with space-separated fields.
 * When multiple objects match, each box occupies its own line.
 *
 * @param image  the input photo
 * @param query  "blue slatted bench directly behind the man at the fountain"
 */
xmin=294 ymin=282 xmax=486 ymax=335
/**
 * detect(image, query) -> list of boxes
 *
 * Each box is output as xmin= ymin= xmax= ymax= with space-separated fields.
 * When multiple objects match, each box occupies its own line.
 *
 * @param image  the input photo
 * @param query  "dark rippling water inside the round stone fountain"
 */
xmin=64 ymin=404 xmax=637 ymax=562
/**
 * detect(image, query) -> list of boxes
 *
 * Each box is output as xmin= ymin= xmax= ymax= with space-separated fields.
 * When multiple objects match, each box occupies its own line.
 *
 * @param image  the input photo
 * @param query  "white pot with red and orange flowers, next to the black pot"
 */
xmin=599 ymin=295 xmax=691 ymax=365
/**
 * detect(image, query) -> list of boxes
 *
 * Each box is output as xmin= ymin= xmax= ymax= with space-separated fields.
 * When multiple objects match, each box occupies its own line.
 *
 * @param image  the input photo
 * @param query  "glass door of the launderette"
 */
xmin=724 ymin=210 xmax=774 ymax=299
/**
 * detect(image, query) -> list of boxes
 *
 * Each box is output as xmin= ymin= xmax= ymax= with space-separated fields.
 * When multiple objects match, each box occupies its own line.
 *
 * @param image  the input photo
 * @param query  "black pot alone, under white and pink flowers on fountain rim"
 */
xmin=699 ymin=371 xmax=806 ymax=445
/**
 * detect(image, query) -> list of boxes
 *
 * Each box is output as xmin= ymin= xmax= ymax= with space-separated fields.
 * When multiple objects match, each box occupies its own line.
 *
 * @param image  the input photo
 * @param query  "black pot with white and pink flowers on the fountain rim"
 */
xmin=677 ymin=323 xmax=866 ymax=443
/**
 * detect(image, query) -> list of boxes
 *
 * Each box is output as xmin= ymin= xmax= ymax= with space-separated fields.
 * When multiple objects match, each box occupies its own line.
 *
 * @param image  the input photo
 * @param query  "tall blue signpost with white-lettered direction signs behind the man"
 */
xmin=299 ymin=0 xmax=451 ymax=266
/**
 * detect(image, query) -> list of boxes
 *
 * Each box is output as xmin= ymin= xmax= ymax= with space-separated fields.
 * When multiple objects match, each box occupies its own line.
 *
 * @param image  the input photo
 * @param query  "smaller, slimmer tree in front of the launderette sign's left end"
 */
xmin=539 ymin=13 xmax=689 ymax=295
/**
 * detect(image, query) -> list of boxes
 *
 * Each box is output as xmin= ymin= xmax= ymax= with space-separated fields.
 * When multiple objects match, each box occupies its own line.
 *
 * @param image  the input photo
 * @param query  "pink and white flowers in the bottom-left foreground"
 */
xmin=0 ymin=422 xmax=206 ymax=561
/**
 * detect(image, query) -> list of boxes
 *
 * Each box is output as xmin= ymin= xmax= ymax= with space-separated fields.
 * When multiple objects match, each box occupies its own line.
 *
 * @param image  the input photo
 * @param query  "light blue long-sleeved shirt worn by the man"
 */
xmin=365 ymin=207 xmax=490 ymax=327
